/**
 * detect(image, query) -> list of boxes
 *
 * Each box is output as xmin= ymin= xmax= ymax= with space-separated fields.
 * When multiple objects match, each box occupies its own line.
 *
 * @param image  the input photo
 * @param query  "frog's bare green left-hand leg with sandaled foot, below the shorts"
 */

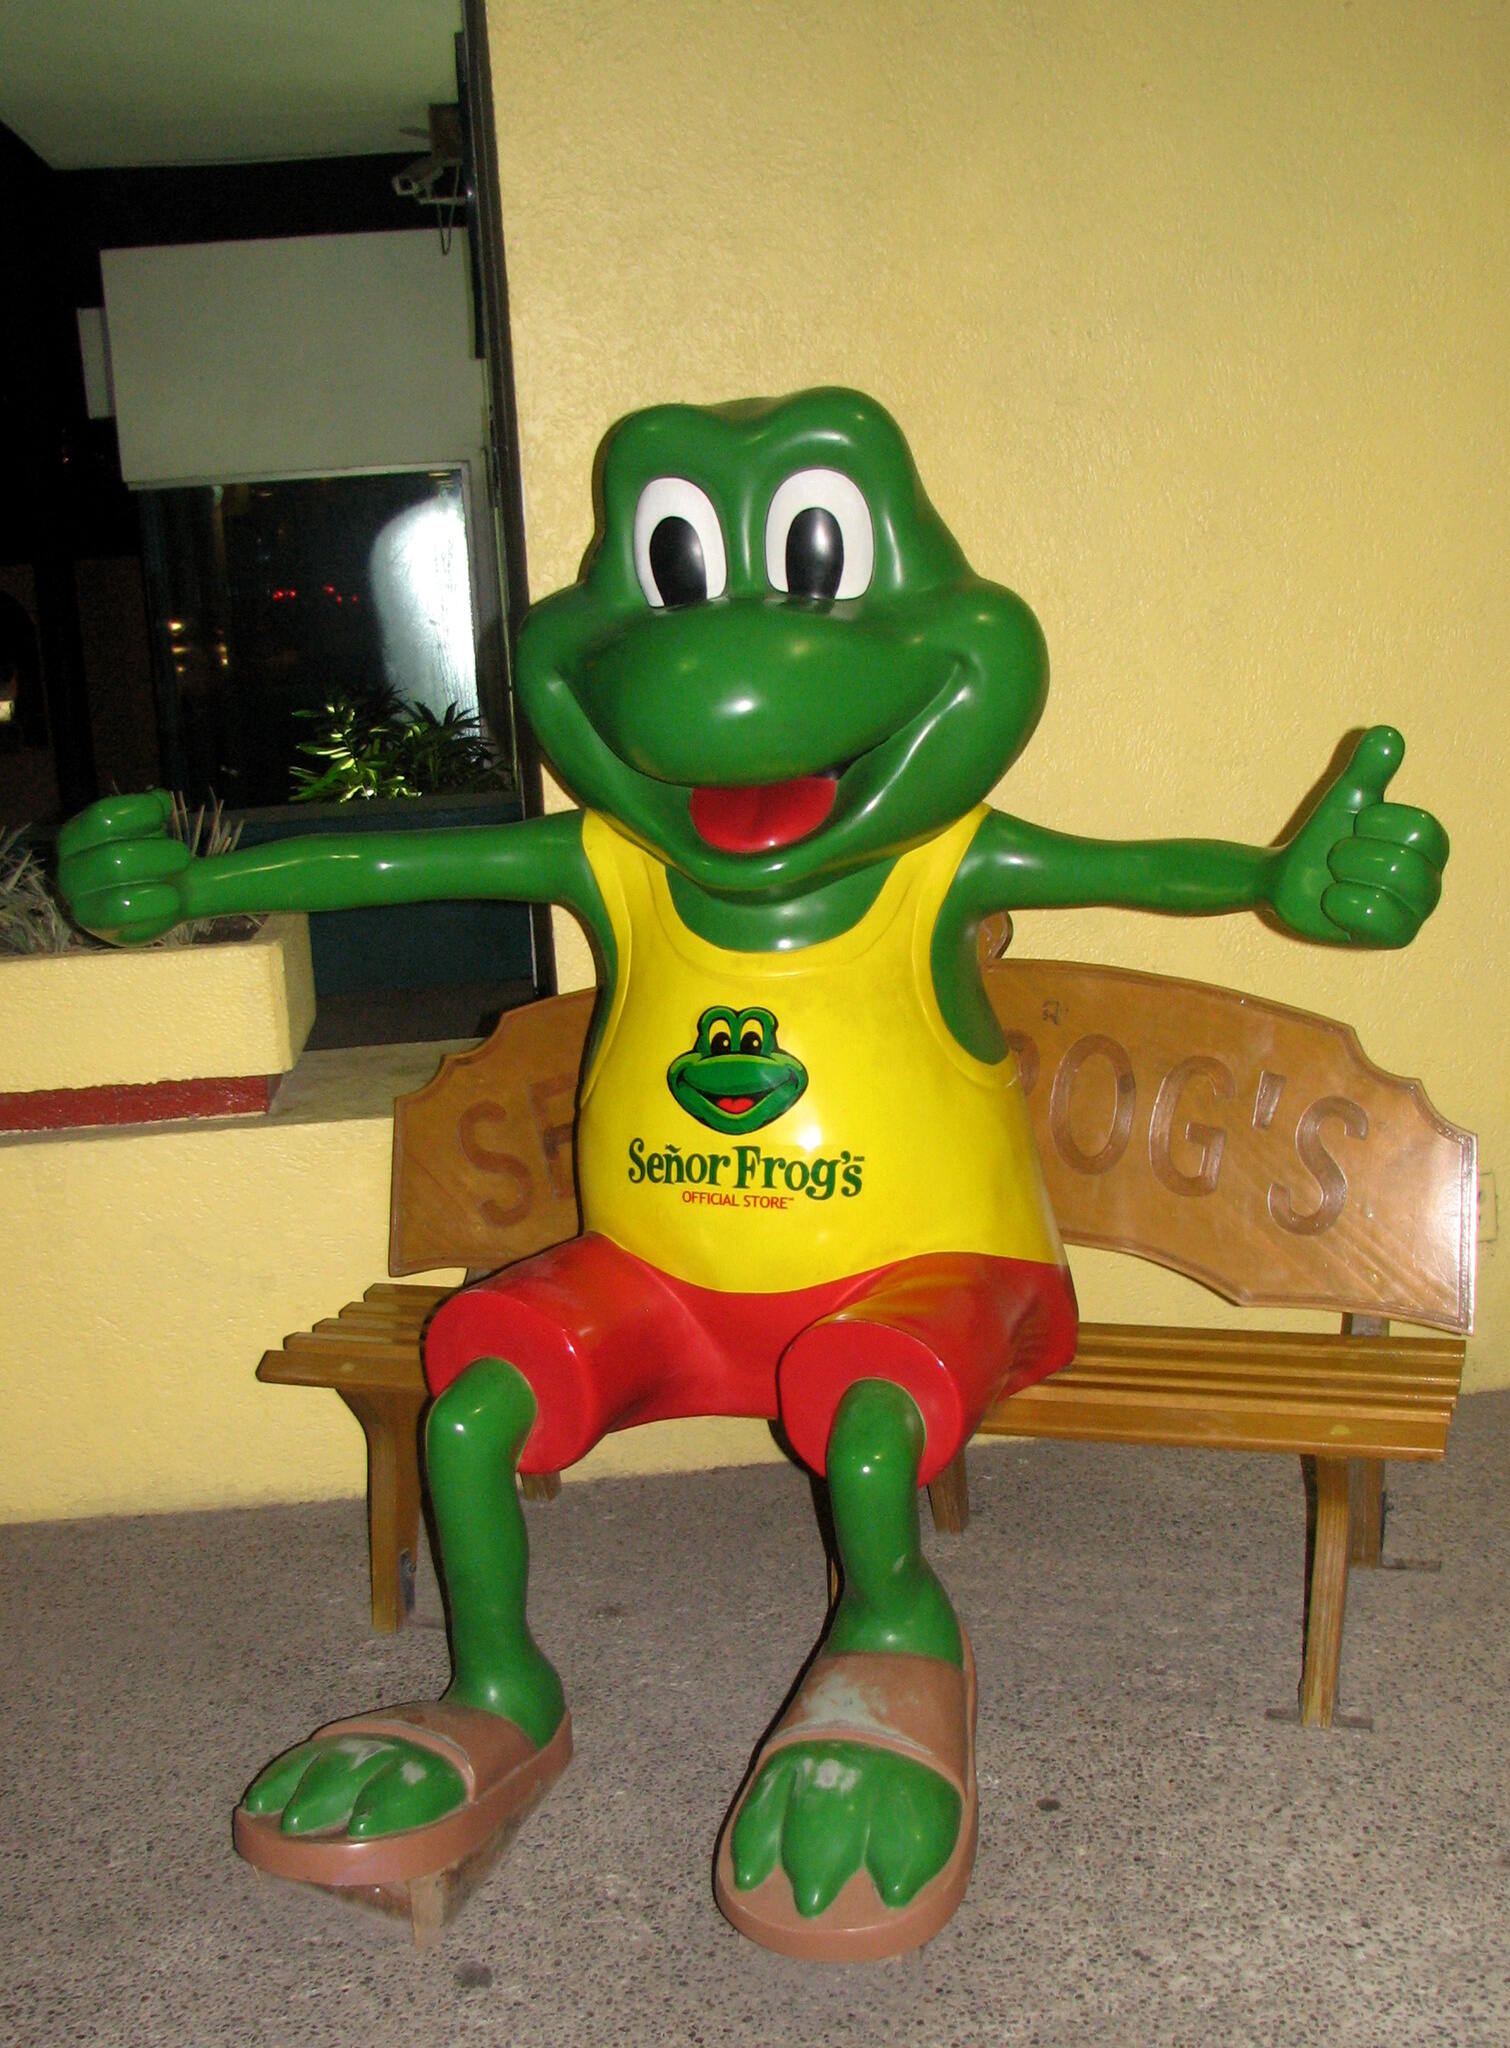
xmin=236 ymin=1358 xmax=572 ymax=1886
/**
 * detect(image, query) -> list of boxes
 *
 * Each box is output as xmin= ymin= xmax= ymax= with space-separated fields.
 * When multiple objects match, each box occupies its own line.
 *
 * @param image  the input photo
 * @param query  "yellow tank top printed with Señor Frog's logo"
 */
xmin=578 ymin=811 xmax=1063 ymax=1294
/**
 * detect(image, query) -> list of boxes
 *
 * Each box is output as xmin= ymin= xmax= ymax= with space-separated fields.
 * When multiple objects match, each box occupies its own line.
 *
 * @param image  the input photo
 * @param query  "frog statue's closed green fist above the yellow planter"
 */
xmin=57 ymin=788 xmax=193 ymax=946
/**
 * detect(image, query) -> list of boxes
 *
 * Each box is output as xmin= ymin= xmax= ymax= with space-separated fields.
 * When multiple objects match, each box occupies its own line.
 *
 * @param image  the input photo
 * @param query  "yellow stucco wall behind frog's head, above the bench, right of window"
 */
xmin=488 ymin=0 xmax=1510 ymax=1386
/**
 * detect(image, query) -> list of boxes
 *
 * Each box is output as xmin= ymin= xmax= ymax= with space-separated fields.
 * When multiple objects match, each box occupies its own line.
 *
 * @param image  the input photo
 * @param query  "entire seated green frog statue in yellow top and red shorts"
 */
xmin=61 ymin=389 xmax=1446 ymax=1958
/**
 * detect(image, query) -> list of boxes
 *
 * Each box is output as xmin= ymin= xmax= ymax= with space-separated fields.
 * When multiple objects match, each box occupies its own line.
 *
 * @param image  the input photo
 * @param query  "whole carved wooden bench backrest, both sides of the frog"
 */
xmin=389 ymin=958 xmax=1477 ymax=1331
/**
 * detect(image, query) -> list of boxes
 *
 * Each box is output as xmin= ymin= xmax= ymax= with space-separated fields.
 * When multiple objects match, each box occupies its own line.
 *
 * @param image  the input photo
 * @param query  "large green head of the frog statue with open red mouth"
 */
xmin=518 ymin=391 xmax=1047 ymax=901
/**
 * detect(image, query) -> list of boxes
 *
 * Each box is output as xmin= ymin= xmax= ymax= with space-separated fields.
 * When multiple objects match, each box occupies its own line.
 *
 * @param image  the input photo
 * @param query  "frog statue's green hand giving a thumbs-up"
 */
xmin=1268 ymin=725 xmax=1449 ymax=946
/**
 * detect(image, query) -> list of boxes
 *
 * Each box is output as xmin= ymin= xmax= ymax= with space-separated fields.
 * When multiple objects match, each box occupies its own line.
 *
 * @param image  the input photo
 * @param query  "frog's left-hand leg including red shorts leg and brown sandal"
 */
xmin=236 ymin=1235 xmax=684 ymax=1884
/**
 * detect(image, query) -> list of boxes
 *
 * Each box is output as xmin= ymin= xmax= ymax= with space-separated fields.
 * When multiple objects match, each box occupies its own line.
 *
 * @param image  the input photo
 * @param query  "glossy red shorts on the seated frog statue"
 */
xmin=424 ymin=1235 xmax=1076 ymax=1485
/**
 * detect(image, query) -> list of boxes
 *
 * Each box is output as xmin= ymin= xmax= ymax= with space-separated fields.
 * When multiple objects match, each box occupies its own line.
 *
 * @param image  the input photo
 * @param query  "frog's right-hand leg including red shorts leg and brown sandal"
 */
xmin=717 ymin=1257 xmax=1076 ymax=1960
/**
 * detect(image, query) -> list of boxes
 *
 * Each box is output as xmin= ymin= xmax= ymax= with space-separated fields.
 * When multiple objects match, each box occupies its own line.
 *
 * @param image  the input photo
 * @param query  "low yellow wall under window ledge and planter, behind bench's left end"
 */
xmin=0 ymin=1047 xmax=774 ymax=1523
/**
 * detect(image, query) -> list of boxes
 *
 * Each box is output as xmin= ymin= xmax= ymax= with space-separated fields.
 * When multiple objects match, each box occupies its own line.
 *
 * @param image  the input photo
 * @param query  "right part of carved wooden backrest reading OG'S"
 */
xmin=985 ymin=958 xmax=1477 ymax=1329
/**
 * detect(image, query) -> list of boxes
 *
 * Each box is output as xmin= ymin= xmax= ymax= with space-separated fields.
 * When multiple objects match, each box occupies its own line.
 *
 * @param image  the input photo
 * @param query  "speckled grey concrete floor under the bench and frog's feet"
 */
xmin=0 ymin=1395 xmax=1510 ymax=2048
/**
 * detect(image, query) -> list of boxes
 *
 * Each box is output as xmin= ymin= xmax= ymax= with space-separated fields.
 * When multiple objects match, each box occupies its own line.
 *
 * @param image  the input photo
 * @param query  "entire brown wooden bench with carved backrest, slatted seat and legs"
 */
xmin=258 ymin=961 xmax=1475 ymax=1726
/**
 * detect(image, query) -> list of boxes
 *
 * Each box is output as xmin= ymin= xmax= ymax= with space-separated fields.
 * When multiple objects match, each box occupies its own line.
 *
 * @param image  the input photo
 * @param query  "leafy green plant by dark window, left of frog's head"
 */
xmin=291 ymin=686 xmax=512 ymax=803
